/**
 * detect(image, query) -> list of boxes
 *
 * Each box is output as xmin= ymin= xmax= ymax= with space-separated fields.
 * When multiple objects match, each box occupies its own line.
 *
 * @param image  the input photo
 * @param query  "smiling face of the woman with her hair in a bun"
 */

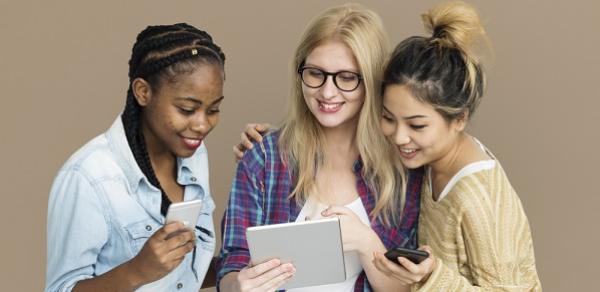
xmin=381 ymin=85 xmax=465 ymax=168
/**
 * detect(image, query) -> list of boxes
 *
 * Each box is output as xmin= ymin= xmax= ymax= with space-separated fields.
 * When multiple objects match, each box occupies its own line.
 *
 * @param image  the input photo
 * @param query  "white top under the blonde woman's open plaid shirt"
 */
xmin=287 ymin=197 xmax=371 ymax=292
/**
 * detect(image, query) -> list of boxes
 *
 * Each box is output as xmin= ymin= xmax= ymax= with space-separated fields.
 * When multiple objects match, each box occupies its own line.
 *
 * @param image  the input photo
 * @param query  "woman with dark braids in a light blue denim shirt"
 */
xmin=46 ymin=23 xmax=225 ymax=291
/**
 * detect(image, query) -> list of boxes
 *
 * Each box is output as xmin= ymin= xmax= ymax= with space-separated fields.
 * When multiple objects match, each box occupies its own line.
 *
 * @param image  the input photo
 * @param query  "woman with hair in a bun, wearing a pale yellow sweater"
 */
xmin=374 ymin=2 xmax=541 ymax=291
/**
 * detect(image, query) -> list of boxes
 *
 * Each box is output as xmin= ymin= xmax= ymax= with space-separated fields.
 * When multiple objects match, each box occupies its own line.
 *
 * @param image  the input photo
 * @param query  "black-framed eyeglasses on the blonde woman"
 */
xmin=298 ymin=67 xmax=362 ymax=92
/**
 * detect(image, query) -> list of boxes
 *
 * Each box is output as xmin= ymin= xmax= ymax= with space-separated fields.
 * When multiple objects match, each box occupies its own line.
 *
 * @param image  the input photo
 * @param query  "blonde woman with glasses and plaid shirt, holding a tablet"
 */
xmin=217 ymin=5 xmax=421 ymax=292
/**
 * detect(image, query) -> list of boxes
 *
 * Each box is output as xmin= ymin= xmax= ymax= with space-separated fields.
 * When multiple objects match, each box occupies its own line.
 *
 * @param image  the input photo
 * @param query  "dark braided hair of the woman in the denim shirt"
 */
xmin=121 ymin=23 xmax=225 ymax=215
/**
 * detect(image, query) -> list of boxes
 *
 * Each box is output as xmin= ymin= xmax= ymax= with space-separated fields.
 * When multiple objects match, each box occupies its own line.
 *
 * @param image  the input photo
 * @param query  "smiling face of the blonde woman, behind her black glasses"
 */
xmin=302 ymin=41 xmax=365 ymax=128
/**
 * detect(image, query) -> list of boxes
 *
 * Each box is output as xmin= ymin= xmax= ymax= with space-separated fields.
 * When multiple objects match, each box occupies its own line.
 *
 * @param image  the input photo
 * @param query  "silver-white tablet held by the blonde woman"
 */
xmin=246 ymin=218 xmax=346 ymax=289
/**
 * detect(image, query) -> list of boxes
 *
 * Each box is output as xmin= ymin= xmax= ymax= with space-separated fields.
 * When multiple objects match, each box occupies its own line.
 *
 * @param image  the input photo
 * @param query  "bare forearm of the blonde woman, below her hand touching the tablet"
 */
xmin=358 ymin=230 xmax=410 ymax=292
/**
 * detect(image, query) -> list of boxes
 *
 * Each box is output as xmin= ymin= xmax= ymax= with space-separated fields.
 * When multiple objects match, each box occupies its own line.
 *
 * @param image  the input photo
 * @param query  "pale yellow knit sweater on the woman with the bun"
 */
xmin=413 ymin=152 xmax=542 ymax=291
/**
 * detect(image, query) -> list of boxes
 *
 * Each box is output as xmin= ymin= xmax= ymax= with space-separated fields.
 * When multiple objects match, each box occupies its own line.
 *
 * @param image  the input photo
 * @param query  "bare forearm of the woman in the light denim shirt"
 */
xmin=73 ymin=261 xmax=145 ymax=292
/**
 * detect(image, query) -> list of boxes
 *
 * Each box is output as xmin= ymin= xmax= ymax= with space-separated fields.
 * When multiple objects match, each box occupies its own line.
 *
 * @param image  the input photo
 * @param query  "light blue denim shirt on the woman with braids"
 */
xmin=45 ymin=117 xmax=215 ymax=291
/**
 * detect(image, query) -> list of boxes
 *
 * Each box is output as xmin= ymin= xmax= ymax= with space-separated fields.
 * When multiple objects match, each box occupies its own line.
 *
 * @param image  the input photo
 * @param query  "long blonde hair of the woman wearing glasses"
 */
xmin=279 ymin=4 xmax=405 ymax=224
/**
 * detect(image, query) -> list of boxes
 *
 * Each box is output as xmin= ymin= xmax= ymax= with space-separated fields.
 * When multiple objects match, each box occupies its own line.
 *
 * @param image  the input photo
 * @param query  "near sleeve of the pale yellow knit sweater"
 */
xmin=415 ymin=175 xmax=541 ymax=291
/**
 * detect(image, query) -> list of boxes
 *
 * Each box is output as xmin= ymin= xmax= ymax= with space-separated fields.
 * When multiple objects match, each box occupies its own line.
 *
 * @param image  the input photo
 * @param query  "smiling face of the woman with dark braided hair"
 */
xmin=133 ymin=63 xmax=223 ymax=157
